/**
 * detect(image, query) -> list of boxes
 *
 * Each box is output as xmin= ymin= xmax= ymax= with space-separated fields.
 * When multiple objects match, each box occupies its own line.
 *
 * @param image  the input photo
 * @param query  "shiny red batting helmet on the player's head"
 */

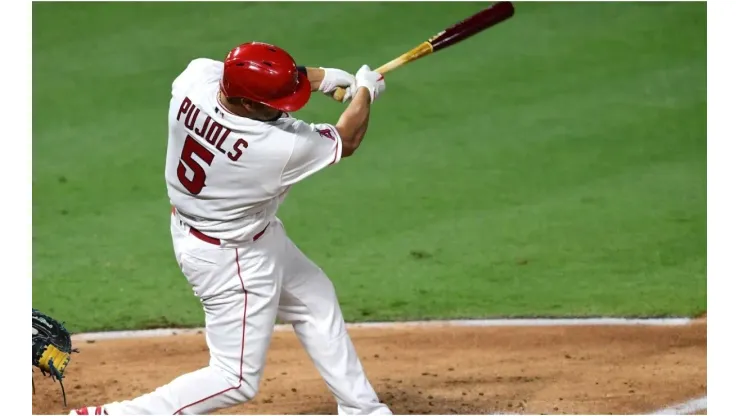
xmin=221 ymin=42 xmax=311 ymax=112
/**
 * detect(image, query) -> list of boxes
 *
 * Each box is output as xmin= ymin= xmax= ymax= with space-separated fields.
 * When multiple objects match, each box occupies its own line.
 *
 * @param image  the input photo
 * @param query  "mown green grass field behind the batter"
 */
xmin=33 ymin=3 xmax=707 ymax=331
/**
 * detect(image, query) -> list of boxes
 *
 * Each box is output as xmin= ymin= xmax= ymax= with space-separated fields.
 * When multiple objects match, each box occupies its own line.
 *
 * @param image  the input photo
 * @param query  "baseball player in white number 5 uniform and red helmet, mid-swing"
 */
xmin=70 ymin=42 xmax=391 ymax=415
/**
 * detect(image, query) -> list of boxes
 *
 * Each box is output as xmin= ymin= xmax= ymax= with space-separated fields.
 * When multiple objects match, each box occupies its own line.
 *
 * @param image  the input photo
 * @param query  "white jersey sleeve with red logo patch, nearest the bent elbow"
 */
xmin=281 ymin=123 xmax=342 ymax=186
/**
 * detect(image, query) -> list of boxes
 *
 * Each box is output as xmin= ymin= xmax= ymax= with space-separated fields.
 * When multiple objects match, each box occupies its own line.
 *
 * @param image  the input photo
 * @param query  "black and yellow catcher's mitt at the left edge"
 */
xmin=31 ymin=309 xmax=77 ymax=406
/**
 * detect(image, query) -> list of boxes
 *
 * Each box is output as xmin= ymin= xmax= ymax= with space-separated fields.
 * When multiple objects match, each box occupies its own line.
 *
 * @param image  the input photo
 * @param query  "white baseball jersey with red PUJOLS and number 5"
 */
xmin=165 ymin=58 xmax=342 ymax=242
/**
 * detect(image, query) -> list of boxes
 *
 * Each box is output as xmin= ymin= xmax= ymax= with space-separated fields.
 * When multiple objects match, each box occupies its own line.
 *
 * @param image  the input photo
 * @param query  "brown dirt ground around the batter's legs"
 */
xmin=33 ymin=321 xmax=707 ymax=414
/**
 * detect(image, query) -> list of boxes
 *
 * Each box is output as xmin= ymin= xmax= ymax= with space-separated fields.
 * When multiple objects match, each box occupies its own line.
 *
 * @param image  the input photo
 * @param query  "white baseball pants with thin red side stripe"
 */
xmin=104 ymin=214 xmax=391 ymax=415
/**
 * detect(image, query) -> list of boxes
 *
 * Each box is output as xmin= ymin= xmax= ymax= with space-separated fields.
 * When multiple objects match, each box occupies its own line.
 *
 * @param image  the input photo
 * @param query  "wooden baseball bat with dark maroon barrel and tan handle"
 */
xmin=333 ymin=1 xmax=514 ymax=101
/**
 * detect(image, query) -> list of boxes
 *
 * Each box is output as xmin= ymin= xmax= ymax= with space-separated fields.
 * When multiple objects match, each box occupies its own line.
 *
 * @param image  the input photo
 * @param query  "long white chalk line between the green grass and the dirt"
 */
xmin=72 ymin=318 xmax=692 ymax=341
